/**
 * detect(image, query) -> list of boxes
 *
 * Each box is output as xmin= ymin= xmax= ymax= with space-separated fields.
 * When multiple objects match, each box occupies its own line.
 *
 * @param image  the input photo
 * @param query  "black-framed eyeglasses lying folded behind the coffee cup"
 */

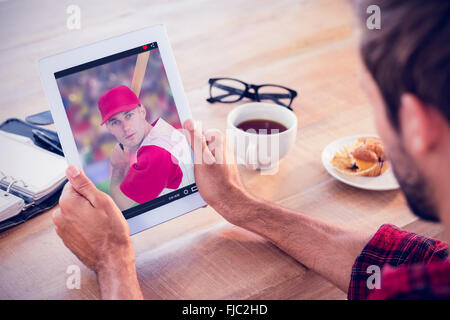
xmin=206 ymin=78 xmax=297 ymax=110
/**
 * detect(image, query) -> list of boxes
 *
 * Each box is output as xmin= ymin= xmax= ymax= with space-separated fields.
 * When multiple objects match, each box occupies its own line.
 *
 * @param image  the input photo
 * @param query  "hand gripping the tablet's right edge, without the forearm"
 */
xmin=184 ymin=119 xmax=251 ymax=225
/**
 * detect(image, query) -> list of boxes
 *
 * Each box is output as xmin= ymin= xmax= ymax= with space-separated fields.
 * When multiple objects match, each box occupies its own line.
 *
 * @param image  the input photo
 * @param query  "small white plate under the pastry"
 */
xmin=322 ymin=134 xmax=400 ymax=191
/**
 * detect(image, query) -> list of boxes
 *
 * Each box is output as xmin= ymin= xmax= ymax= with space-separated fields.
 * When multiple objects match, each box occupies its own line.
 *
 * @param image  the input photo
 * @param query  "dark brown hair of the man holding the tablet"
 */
xmin=356 ymin=0 xmax=450 ymax=128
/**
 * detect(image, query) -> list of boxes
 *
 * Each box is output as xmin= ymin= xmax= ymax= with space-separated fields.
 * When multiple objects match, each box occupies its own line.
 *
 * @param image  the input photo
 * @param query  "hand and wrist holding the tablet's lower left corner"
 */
xmin=53 ymin=166 xmax=142 ymax=299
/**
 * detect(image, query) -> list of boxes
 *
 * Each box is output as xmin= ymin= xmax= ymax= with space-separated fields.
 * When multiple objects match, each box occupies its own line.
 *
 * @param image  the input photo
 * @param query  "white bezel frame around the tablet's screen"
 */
xmin=39 ymin=25 xmax=206 ymax=235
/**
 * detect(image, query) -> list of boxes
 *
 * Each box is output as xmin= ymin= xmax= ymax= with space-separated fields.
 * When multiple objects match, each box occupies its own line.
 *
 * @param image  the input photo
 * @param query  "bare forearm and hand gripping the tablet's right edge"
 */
xmin=184 ymin=120 xmax=370 ymax=292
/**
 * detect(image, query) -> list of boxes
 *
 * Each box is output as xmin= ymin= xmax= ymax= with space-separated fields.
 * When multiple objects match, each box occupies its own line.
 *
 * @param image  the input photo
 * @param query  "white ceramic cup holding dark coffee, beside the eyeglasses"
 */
xmin=227 ymin=102 xmax=297 ymax=172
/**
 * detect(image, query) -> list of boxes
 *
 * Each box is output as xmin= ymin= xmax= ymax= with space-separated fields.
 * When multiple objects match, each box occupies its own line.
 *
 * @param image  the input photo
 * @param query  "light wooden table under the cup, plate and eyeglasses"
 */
xmin=0 ymin=0 xmax=443 ymax=299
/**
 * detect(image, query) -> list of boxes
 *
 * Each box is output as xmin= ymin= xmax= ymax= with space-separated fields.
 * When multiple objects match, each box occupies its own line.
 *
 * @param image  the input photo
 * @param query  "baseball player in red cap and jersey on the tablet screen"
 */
xmin=98 ymin=86 xmax=193 ymax=210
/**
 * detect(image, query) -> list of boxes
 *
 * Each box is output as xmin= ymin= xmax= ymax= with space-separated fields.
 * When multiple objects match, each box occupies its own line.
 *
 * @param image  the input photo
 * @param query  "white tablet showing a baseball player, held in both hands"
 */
xmin=39 ymin=25 xmax=205 ymax=234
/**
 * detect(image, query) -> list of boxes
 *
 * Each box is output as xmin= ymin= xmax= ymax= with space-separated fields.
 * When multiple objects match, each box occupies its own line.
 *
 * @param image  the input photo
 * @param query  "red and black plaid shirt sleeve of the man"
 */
xmin=348 ymin=224 xmax=450 ymax=300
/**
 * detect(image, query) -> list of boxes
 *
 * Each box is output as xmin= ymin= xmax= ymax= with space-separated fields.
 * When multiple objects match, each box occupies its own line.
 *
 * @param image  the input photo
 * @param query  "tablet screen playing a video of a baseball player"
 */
xmin=55 ymin=42 xmax=197 ymax=219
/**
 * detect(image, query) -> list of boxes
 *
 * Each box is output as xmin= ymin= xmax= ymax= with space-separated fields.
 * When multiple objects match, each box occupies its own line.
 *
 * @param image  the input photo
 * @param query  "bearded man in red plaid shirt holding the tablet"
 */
xmin=54 ymin=0 xmax=450 ymax=299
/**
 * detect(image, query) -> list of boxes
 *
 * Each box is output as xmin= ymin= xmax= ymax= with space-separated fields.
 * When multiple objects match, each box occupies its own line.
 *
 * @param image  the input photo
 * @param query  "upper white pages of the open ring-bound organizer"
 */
xmin=0 ymin=131 xmax=67 ymax=221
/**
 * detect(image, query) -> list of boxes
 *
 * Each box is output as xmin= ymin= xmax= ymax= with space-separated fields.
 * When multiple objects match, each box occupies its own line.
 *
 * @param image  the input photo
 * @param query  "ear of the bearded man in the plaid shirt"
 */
xmin=399 ymin=93 xmax=445 ymax=155
